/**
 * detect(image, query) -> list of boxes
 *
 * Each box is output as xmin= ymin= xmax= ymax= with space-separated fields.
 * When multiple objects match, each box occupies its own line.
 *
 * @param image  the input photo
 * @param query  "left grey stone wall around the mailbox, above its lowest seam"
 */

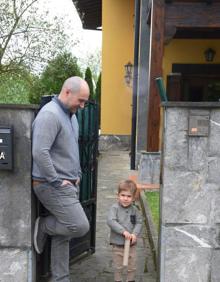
xmin=0 ymin=109 xmax=34 ymax=247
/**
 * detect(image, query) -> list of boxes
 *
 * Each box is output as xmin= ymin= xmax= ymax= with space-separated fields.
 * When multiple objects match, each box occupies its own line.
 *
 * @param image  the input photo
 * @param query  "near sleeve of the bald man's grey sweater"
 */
xmin=32 ymin=111 xmax=62 ymax=186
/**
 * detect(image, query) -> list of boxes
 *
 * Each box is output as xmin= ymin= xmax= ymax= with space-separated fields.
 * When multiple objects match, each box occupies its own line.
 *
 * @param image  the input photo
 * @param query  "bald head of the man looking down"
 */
xmin=58 ymin=76 xmax=89 ymax=113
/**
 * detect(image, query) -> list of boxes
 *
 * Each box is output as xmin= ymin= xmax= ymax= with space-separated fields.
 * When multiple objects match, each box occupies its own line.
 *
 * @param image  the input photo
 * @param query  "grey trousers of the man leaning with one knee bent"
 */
xmin=34 ymin=182 xmax=89 ymax=282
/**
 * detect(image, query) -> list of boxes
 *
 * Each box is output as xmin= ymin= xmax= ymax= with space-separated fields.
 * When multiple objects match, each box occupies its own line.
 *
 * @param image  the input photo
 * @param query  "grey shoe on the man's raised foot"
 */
xmin=34 ymin=217 xmax=48 ymax=254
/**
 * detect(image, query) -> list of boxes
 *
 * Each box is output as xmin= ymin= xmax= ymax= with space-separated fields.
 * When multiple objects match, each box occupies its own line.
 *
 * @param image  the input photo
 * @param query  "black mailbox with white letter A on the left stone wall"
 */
xmin=0 ymin=126 xmax=13 ymax=170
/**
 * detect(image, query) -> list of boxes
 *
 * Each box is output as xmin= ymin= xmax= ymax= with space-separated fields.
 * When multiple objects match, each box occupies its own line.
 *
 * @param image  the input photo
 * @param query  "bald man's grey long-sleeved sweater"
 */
xmin=32 ymin=97 xmax=81 ymax=186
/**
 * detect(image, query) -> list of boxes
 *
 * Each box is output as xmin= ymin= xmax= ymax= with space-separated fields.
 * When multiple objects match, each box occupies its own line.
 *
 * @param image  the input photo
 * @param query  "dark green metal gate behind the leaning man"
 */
xmin=37 ymin=96 xmax=99 ymax=281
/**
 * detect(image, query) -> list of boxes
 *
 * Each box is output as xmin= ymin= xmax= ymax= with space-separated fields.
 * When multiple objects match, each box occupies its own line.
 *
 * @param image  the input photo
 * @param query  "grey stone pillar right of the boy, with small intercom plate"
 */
xmin=159 ymin=102 xmax=220 ymax=282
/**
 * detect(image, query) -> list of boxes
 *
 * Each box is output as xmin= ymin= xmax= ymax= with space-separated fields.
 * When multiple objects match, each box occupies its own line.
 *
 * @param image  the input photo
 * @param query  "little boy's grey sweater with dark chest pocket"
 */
xmin=107 ymin=203 xmax=142 ymax=245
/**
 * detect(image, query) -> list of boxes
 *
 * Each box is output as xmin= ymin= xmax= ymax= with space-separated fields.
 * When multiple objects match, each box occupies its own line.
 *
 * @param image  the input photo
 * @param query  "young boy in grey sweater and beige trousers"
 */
xmin=107 ymin=180 xmax=142 ymax=282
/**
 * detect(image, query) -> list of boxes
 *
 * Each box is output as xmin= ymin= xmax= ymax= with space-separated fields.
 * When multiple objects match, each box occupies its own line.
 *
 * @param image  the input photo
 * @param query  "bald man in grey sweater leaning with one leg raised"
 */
xmin=32 ymin=77 xmax=89 ymax=282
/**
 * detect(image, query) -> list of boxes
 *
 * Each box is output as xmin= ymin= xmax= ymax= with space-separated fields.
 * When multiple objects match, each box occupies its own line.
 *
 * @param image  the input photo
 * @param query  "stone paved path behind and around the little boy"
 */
xmin=70 ymin=151 xmax=156 ymax=282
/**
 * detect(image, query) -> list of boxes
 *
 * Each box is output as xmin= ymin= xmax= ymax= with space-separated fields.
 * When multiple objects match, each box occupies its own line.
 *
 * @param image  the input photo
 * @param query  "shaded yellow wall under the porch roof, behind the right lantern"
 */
xmin=163 ymin=39 xmax=220 ymax=83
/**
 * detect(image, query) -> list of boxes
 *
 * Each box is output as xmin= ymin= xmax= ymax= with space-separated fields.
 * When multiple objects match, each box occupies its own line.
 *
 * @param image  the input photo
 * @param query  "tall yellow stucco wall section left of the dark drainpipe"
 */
xmin=101 ymin=0 xmax=134 ymax=135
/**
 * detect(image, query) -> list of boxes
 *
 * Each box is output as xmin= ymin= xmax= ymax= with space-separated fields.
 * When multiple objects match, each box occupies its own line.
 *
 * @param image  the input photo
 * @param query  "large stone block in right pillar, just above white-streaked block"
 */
xmin=162 ymin=172 xmax=215 ymax=224
